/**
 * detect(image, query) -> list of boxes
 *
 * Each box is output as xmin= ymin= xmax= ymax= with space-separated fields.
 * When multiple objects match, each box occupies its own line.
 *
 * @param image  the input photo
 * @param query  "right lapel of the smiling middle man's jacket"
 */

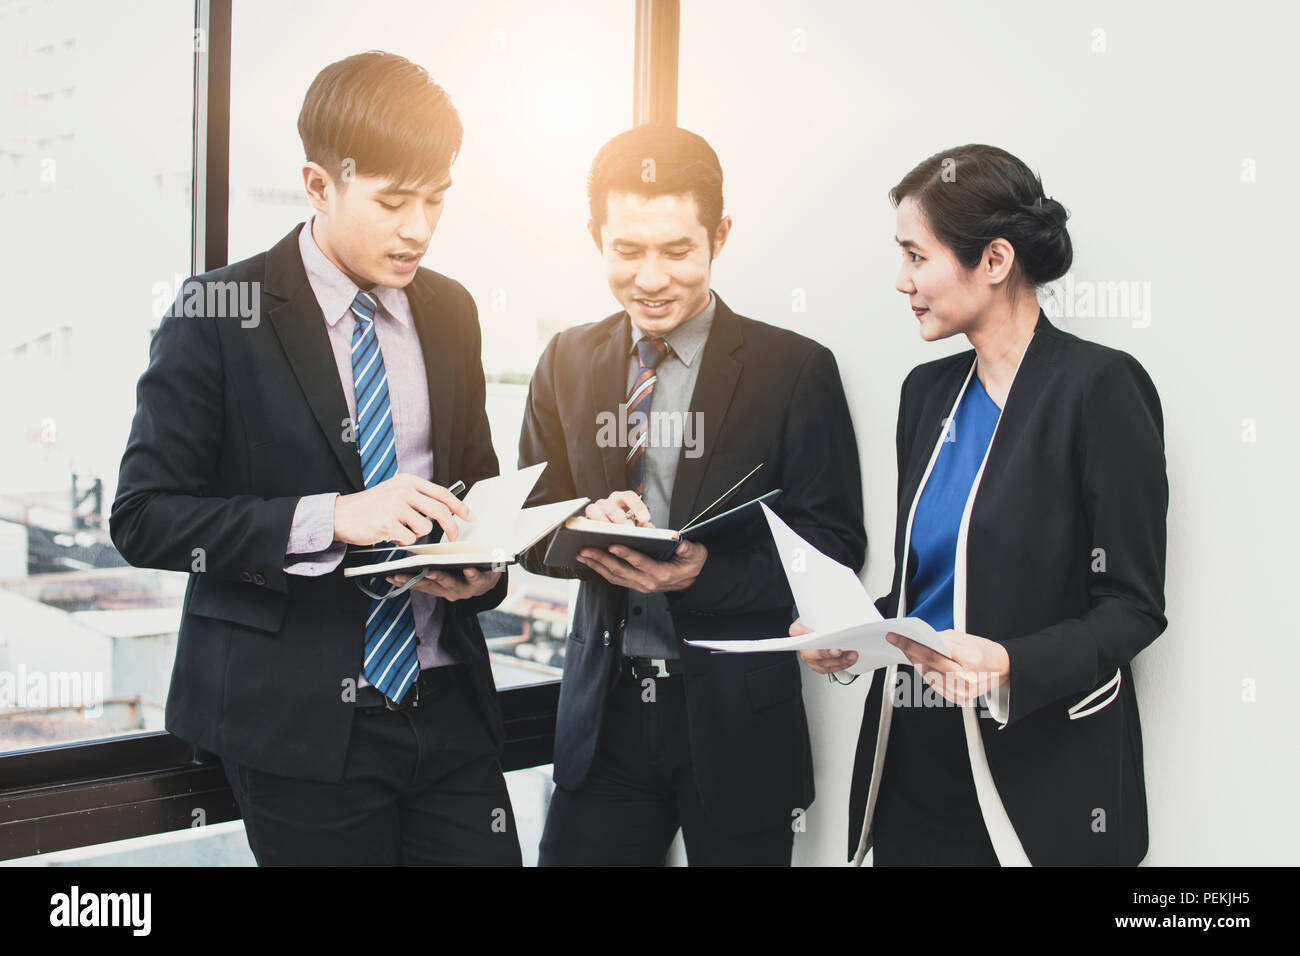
xmin=668 ymin=293 xmax=757 ymax=528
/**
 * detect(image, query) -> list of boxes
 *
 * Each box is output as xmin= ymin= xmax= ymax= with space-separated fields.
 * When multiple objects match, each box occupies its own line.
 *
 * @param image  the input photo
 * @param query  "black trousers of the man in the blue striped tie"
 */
xmin=225 ymin=665 xmax=521 ymax=866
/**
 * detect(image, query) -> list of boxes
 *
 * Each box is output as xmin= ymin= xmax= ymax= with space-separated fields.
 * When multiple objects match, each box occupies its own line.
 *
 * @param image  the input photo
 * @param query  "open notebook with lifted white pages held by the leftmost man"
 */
xmin=343 ymin=462 xmax=589 ymax=578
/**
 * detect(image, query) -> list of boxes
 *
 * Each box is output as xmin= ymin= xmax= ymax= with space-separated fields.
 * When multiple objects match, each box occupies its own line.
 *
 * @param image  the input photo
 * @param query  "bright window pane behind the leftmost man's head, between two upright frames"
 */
xmin=230 ymin=0 xmax=634 ymax=687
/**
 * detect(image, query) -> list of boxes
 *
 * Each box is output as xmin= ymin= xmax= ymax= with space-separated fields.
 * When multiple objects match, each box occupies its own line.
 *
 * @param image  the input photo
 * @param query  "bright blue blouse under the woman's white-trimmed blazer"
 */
xmin=907 ymin=375 xmax=1002 ymax=631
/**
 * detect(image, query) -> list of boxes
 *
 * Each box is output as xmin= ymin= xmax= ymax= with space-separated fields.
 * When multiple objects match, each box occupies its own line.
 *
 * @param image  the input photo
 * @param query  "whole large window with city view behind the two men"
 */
xmin=0 ymin=0 xmax=650 ymax=862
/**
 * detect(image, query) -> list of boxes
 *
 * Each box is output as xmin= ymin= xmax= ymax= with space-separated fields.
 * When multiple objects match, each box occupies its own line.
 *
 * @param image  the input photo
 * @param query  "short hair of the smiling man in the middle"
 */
xmin=586 ymin=122 xmax=723 ymax=248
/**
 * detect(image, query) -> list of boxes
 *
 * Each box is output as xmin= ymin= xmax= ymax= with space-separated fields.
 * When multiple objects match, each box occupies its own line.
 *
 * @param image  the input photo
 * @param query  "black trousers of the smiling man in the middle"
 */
xmin=538 ymin=667 xmax=794 ymax=866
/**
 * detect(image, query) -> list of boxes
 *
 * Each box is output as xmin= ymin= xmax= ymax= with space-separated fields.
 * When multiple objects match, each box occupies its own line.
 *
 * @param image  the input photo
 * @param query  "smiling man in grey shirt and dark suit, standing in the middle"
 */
xmin=519 ymin=125 xmax=866 ymax=865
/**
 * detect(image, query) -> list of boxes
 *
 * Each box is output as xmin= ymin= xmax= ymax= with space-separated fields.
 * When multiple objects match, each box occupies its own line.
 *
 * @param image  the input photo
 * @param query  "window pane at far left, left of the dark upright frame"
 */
xmin=0 ymin=0 xmax=194 ymax=750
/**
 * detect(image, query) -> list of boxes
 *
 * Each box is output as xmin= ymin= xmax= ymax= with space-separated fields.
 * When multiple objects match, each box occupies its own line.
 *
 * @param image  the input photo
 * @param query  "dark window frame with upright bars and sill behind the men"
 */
xmin=0 ymin=0 xmax=681 ymax=860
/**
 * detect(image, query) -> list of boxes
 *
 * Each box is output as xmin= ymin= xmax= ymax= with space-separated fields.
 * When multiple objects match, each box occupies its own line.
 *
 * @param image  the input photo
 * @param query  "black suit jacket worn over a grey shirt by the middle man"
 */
xmin=519 ymin=298 xmax=866 ymax=832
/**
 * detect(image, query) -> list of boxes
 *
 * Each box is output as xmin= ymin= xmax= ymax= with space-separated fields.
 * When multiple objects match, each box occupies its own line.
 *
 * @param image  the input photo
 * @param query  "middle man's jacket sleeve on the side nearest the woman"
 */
xmin=668 ymin=346 xmax=867 ymax=614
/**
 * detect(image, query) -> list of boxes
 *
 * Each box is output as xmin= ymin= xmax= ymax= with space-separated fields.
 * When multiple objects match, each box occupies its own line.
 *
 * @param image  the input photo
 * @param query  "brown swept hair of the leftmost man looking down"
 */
xmin=298 ymin=49 xmax=463 ymax=189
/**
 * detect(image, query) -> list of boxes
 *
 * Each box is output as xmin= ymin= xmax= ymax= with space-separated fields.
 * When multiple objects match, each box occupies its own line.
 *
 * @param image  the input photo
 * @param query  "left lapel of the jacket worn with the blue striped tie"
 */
xmin=263 ymin=226 xmax=364 ymax=492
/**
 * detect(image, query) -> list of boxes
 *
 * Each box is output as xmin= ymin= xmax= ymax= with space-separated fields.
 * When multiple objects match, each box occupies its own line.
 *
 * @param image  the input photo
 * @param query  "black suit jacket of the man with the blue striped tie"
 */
xmin=109 ymin=226 xmax=506 ymax=780
